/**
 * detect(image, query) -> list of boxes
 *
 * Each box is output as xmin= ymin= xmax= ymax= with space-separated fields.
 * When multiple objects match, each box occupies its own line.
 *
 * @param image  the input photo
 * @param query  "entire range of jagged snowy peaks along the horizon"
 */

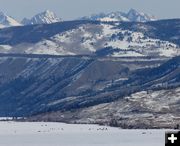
xmin=0 ymin=9 xmax=156 ymax=28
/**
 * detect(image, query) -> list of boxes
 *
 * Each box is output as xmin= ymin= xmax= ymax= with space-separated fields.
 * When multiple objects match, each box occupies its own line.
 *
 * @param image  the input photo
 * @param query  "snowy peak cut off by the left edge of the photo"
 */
xmin=0 ymin=12 xmax=21 ymax=28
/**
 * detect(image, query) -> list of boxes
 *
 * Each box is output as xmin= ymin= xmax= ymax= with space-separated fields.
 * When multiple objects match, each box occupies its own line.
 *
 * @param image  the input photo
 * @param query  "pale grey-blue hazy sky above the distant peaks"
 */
xmin=0 ymin=0 xmax=180 ymax=20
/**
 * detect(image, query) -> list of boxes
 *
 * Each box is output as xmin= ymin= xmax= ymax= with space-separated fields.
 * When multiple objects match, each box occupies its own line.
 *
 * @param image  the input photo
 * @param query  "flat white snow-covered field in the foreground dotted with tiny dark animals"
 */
xmin=0 ymin=122 xmax=165 ymax=146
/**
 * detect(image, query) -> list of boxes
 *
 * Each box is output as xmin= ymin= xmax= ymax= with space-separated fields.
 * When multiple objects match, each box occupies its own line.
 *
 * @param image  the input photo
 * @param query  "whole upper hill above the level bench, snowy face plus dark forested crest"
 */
xmin=0 ymin=20 xmax=180 ymax=57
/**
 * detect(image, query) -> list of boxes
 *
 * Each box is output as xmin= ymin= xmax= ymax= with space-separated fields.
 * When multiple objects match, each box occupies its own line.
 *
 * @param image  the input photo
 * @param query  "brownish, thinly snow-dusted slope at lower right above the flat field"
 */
xmin=39 ymin=88 xmax=180 ymax=128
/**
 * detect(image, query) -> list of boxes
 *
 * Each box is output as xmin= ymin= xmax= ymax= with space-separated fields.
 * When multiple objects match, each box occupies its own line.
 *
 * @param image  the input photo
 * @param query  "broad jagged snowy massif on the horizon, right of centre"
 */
xmin=80 ymin=9 xmax=156 ymax=22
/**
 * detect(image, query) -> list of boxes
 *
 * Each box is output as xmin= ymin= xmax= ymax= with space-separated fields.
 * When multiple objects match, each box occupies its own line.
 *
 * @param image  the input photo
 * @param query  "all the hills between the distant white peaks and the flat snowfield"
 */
xmin=0 ymin=12 xmax=180 ymax=128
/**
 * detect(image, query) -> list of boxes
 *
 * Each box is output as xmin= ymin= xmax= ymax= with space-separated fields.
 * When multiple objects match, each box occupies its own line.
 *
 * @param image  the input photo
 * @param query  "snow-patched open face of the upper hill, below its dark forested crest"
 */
xmin=0 ymin=23 xmax=180 ymax=57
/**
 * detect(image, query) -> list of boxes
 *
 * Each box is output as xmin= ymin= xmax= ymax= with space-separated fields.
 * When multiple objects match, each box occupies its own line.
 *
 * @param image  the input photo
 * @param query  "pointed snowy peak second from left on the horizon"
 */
xmin=21 ymin=10 xmax=62 ymax=25
